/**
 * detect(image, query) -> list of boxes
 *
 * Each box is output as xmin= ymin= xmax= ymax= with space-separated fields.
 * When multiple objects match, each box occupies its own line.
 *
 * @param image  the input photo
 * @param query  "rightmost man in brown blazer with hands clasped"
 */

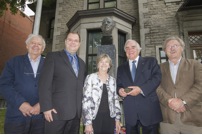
xmin=157 ymin=36 xmax=202 ymax=134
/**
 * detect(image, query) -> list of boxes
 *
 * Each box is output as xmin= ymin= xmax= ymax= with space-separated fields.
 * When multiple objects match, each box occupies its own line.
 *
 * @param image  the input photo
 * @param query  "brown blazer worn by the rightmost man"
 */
xmin=157 ymin=58 xmax=202 ymax=126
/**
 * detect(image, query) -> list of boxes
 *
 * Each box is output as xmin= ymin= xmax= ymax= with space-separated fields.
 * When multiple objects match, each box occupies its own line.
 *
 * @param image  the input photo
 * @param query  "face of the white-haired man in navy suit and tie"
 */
xmin=125 ymin=41 xmax=140 ymax=60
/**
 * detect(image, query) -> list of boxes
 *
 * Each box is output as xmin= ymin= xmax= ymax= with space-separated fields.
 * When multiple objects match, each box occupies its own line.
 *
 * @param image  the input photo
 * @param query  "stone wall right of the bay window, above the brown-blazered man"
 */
xmin=139 ymin=0 xmax=182 ymax=57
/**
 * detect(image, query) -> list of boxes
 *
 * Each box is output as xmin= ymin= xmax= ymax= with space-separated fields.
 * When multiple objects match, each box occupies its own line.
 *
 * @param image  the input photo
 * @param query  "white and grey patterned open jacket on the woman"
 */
xmin=82 ymin=73 xmax=121 ymax=125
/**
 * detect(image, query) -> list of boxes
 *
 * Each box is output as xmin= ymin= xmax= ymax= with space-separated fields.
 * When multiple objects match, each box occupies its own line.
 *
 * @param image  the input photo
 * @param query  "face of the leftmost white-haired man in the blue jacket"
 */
xmin=26 ymin=37 xmax=44 ymax=56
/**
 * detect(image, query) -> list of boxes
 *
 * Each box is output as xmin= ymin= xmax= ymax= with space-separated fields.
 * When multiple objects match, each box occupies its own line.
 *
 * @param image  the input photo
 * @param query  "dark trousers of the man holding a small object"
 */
xmin=126 ymin=120 xmax=159 ymax=134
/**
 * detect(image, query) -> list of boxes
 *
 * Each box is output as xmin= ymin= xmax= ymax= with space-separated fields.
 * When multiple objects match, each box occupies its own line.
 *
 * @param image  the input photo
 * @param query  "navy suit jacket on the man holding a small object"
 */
xmin=117 ymin=57 xmax=162 ymax=126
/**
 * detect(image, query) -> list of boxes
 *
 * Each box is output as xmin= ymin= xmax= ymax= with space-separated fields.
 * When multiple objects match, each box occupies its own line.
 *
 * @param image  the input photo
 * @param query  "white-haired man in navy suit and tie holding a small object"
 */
xmin=117 ymin=39 xmax=162 ymax=134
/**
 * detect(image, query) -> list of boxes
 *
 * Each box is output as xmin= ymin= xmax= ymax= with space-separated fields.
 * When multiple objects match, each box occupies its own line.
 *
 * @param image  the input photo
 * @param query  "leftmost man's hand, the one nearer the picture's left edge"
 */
xmin=19 ymin=102 xmax=33 ymax=117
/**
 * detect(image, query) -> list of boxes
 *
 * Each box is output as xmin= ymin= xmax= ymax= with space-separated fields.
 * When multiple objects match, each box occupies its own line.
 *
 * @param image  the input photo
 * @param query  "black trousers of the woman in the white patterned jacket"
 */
xmin=93 ymin=112 xmax=115 ymax=134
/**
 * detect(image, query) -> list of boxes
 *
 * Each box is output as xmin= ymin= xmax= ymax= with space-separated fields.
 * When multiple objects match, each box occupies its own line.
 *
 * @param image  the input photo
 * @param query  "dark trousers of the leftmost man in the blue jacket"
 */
xmin=4 ymin=117 xmax=45 ymax=134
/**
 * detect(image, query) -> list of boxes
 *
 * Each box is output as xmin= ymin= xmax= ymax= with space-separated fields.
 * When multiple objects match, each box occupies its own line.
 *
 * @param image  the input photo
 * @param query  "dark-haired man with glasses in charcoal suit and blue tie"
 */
xmin=39 ymin=32 xmax=85 ymax=134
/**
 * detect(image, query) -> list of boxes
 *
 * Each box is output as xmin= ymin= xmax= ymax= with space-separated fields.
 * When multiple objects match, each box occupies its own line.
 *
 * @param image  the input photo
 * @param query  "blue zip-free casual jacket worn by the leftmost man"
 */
xmin=0 ymin=54 xmax=44 ymax=121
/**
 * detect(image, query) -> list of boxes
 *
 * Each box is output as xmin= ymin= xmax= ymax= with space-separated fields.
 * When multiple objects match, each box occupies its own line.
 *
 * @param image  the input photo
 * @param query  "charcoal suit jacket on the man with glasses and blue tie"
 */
xmin=39 ymin=50 xmax=85 ymax=120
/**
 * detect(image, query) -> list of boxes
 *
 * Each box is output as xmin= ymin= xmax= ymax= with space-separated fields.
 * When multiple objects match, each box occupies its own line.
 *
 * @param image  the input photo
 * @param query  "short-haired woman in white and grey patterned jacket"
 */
xmin=82 ymin=54 xmax=121 ymax=134
